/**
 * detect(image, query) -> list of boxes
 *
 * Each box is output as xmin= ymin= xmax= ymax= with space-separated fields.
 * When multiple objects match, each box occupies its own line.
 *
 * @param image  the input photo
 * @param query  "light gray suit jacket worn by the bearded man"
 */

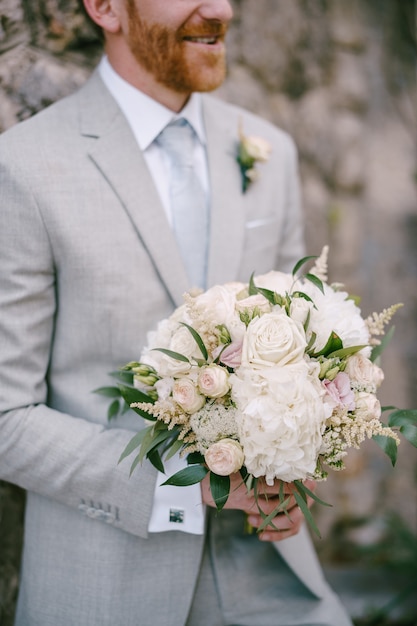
xmin=0 ymin=74 xmax=324 ymax=626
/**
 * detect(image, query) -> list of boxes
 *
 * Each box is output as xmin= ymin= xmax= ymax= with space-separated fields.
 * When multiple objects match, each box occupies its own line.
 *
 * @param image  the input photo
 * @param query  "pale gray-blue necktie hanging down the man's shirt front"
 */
xmin=157 ymin=118 xmax=209 ymax=289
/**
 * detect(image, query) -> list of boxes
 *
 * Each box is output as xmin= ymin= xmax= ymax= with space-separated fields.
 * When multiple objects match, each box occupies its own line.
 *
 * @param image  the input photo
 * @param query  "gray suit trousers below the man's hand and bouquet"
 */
xmin=186 ymin=511 xmax=352 ymax=626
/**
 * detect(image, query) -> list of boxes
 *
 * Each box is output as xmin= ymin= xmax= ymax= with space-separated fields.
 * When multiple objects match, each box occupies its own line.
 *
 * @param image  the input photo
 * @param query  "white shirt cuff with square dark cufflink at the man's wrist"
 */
xmin=148 ymin=455 xmax=206 ymax=535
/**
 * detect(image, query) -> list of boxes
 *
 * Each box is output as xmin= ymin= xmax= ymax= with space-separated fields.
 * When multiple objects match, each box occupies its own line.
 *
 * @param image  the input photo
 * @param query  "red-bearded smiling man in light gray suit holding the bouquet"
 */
xmin=0 ymin=0 xmax=351 ymax=626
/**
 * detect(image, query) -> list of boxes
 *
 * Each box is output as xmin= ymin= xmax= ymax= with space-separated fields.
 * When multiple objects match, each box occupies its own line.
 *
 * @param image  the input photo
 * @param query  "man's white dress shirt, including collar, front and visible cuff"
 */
xmin=98 ymin=57 xmax=209 ymax=535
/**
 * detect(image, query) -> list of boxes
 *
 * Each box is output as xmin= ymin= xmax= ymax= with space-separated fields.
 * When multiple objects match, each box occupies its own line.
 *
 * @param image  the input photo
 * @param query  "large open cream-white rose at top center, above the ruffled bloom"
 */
xmin=242 ymin=309 xmax=307 ymax=367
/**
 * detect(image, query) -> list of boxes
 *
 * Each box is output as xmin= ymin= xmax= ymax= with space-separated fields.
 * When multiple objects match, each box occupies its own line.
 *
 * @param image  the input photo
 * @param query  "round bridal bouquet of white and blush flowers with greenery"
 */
xmin=99 ymin=247 xmax=417 ymax=532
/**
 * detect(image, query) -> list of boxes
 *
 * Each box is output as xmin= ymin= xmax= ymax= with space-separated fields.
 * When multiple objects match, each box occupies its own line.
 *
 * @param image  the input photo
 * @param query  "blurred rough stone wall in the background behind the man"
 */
xmin=0 ymin=0 xmax=417 ymax=618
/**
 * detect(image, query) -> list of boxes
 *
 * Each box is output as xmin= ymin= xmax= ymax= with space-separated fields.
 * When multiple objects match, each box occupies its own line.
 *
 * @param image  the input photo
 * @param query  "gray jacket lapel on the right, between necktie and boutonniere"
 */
xmin=203 ymin=96 xmax=245 ymax=286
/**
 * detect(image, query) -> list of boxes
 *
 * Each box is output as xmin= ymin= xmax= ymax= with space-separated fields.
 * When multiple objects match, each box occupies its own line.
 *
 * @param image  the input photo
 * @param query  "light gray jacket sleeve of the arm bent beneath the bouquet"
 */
xmin=0 ymin=150 xmax=155 ymax=537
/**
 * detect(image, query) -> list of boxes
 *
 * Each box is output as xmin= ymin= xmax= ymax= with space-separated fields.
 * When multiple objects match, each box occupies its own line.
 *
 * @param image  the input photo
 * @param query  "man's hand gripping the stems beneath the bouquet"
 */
xmin=201 ymin=473 xmax=315 ymax=541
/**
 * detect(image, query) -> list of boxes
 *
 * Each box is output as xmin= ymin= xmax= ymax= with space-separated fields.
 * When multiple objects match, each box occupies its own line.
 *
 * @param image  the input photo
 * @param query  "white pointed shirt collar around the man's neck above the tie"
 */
xmin=98 ymin=56 xmax=206 ymax=150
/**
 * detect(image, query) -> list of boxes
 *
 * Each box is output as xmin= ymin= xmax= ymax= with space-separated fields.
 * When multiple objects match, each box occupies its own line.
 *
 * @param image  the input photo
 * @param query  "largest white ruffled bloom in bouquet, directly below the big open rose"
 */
xmin=231 ymin=361 xmax=327 ymax=484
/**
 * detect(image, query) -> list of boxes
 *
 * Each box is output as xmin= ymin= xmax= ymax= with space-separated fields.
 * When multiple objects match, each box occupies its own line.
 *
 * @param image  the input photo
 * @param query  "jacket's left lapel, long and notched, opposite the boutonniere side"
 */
xmin=80 ymin=74 xmax=190 ymax=305
